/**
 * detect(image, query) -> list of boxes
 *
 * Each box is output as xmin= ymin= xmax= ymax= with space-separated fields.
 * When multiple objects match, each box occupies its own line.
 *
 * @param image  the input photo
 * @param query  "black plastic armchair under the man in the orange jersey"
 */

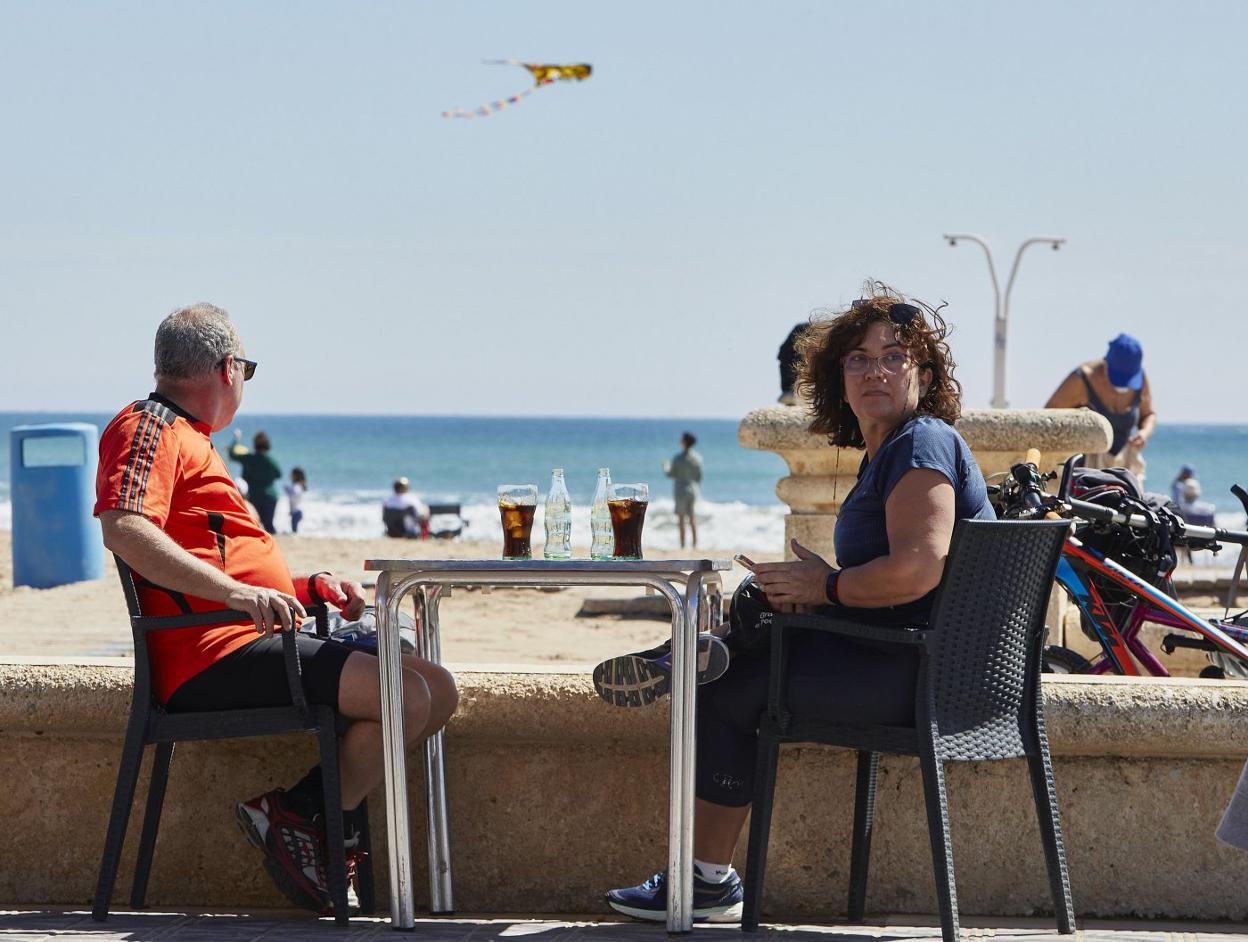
xmin=91 ymin=556 xmax=374 ymax=923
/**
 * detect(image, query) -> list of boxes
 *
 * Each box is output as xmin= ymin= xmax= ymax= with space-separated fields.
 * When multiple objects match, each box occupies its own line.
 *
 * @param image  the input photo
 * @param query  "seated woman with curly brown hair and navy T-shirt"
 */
xmin=607 ymin=283 xmax=993 ymax=921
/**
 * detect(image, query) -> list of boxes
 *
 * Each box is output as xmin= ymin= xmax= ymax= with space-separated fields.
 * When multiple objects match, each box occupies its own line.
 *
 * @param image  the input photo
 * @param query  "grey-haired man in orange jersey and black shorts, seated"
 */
xmin=95 ymin=303 xmax=457 ymax=912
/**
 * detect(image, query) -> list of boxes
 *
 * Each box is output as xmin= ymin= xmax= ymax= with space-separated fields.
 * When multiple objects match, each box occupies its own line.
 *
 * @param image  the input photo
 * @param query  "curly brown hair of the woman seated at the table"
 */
xmin=796 ymin=281 xmax=962 ymax=448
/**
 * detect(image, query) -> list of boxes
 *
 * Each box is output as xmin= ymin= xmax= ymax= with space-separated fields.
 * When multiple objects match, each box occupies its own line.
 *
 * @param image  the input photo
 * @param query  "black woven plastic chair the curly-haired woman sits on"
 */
xmin=741 ymin=520 xmax=1075 ymax=942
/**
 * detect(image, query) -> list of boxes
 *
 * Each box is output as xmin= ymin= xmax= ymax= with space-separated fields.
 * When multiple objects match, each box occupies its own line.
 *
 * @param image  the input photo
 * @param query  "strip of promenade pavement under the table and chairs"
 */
xmin=0 ymin=908 xmax=1248 ymax=942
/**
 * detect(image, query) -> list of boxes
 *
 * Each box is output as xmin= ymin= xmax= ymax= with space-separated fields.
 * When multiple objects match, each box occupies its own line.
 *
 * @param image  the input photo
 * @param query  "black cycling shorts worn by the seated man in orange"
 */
xmin=166 ymin=634 xmax=376 ymax=712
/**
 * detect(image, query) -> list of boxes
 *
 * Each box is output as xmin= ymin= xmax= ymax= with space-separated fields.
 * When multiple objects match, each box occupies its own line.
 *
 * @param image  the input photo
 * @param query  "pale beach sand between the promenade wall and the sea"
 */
xmin=0 ymin=532 xmax=780 ymax=668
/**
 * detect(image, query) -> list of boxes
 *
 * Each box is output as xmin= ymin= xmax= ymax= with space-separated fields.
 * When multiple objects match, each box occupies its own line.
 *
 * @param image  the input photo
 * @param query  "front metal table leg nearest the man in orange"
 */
xmin=376 ymin=571 xmax=416 ymax=930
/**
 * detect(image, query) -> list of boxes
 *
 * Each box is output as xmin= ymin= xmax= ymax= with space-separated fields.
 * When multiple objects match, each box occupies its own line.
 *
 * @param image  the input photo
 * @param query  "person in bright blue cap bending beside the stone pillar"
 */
xmin=1045 ymin=333 xmax=1157 ymax=484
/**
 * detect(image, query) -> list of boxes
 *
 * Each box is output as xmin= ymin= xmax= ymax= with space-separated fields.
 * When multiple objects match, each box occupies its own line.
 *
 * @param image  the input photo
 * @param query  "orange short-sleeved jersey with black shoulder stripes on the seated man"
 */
xmin=95 ymin=393 xmax=295 ymax=702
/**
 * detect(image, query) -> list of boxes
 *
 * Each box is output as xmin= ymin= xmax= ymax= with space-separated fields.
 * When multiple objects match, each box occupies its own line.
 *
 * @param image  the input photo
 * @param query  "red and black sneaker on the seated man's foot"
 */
xmin=236 ymin=789 xmax=332 ymax=912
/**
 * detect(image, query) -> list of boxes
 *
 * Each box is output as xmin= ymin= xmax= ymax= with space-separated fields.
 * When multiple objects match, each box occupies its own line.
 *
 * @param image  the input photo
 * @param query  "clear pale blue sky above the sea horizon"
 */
xmin=0 ymin=0 xmax=1248 ymax=422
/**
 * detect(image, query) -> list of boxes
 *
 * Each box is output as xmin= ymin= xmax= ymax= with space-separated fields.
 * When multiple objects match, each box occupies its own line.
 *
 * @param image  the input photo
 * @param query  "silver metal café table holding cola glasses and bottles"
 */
xmin=364 ymin=559 xmax=731 ymax=932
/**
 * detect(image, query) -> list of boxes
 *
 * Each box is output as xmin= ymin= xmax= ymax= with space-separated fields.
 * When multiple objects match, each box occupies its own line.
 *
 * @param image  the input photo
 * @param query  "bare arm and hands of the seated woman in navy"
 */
xmin=756 ymin=468 xmax=955 ymax=609
